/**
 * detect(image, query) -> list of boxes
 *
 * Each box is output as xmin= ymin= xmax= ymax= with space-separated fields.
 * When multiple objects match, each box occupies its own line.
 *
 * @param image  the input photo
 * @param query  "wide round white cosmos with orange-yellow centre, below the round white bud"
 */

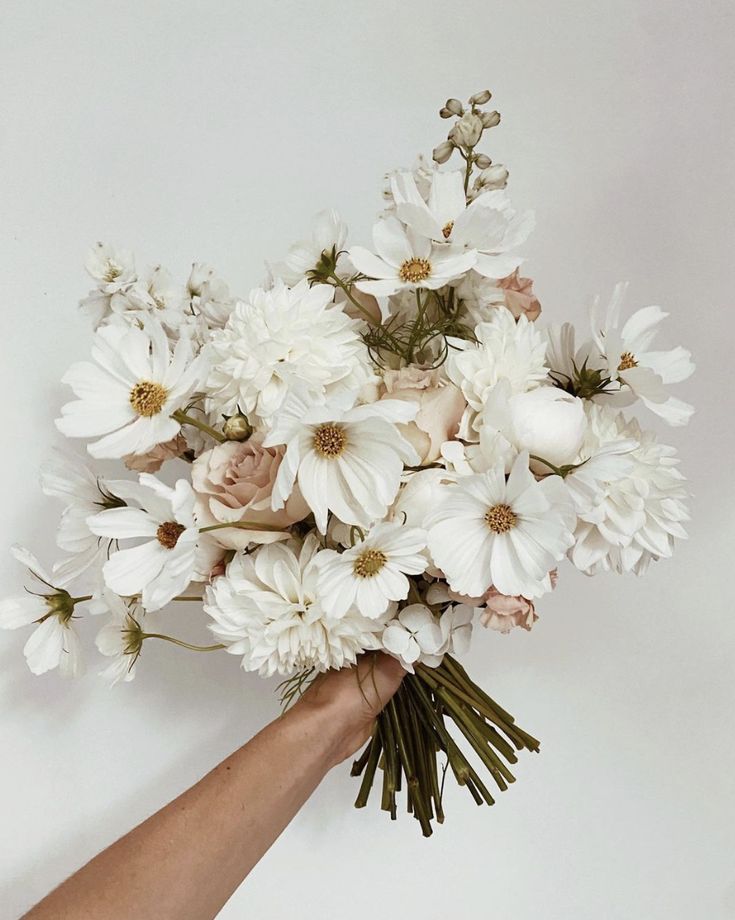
xmin=428 ymin=452 xmax=576 ymax=598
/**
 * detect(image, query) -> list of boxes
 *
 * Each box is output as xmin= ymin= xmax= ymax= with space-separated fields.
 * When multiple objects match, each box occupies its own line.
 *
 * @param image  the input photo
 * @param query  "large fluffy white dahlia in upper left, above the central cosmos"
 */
xmin=206 ymin=281 xmax=373 ymax=422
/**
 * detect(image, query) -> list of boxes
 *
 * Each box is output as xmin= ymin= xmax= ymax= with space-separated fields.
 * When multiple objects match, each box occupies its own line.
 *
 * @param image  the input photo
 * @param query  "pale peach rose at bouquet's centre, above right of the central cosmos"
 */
xmin=380 ymin=367 xmax=467 ymax=464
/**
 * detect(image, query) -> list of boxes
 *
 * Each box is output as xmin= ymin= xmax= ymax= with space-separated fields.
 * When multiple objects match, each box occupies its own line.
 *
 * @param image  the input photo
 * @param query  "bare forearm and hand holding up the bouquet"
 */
xmin=25 ymin=654 xmax=405 ymax=920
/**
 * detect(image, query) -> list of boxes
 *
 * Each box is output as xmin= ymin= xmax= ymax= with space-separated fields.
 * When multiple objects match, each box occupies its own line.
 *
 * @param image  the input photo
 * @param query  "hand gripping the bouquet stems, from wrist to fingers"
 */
xmin=291 ymin=652 xmax=406 ymax=766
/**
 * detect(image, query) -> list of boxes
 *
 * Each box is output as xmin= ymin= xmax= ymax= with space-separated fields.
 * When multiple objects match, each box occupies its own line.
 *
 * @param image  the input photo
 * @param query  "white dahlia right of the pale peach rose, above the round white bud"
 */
xmin=446 ymin=307 xmax=548 ymax=437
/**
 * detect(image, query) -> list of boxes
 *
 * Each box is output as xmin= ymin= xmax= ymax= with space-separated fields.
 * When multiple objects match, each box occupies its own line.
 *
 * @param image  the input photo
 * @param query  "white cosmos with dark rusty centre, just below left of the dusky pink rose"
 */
xmin=89 ymin=473 xmax=207 ymax=610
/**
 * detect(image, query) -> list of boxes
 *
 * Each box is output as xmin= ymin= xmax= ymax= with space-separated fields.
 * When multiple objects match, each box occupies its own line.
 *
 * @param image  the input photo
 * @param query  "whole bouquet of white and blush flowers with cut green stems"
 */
xmin=0 ymin=91 xmax=693 ymax=836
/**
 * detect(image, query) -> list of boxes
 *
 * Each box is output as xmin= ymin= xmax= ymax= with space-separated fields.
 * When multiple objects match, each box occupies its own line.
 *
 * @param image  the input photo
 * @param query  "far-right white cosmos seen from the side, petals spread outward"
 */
xmin=592 ymin=284 xmax=694 ymax=425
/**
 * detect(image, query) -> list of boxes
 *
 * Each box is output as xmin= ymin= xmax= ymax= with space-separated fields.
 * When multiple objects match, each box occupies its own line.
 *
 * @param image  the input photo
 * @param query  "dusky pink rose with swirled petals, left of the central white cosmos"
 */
xmin=191 ymin=434 xmax=309 ymax=550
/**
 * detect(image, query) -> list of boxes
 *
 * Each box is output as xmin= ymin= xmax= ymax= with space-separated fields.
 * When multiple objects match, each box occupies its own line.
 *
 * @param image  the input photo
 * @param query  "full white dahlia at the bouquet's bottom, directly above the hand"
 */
xmin=204 ymin=534 xmax=383 ymax=677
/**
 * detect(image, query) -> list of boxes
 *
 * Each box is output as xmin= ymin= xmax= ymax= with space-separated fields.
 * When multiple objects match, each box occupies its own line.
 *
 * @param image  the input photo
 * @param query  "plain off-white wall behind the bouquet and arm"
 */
xmin=0 ymin=0 xmax=735 ymax=920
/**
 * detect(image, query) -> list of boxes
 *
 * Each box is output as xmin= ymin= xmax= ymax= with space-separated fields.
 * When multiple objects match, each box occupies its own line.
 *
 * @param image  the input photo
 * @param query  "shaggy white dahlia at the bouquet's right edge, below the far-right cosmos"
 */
xmin=567 ymin=405 xmax=689 ymax=575
